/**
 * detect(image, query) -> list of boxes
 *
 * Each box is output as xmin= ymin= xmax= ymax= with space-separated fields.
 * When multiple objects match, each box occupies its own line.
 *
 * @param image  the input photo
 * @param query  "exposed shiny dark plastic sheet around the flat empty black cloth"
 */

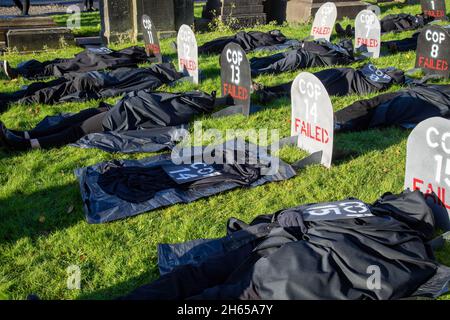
xmin=75 ymin=142 xmax=296 ymax=223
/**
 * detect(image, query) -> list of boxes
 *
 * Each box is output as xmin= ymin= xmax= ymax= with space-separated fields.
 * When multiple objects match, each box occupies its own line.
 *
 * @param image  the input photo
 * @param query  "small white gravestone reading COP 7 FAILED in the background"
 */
xmin=355 ymin=10 xmax=381 ymax=58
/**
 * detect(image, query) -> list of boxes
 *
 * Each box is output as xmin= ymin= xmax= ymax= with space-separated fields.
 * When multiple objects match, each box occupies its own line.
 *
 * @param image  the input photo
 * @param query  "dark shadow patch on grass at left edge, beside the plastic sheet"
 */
xmin=0 ymin=183 xmax=84 ymax=243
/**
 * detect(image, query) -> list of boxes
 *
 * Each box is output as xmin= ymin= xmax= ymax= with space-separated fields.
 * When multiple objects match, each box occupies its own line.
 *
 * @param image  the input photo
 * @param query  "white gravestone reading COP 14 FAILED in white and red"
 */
xmin=291 ymin=72 xmax=334 ymax=168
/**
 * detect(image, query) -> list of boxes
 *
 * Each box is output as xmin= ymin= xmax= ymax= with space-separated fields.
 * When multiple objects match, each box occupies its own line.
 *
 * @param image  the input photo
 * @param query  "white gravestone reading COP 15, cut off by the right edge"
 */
xmin=405 ymin=117 xmax=450 ymax=230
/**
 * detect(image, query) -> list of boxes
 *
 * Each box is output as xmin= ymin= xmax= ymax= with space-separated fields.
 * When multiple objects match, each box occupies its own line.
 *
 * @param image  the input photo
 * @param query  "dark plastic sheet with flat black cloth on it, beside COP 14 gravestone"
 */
xmin=75 ymin=142 xmax=296 ymax=223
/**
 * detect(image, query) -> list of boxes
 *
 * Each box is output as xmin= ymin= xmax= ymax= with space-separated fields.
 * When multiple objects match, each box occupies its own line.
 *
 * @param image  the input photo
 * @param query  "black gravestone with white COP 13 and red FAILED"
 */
xmin=220 ymin=43 xmax=252 ymax=116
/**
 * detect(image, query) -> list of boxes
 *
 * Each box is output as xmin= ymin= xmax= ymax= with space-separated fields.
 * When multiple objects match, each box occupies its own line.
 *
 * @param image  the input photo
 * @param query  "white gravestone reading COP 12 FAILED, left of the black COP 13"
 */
xmin=177 ymin=24 xmax=199 ymax=84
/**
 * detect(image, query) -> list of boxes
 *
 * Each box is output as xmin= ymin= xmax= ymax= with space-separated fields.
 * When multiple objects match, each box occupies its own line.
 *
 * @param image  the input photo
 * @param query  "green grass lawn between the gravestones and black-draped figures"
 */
xmin=0 ymin=1 xmax=450 ymax=299
